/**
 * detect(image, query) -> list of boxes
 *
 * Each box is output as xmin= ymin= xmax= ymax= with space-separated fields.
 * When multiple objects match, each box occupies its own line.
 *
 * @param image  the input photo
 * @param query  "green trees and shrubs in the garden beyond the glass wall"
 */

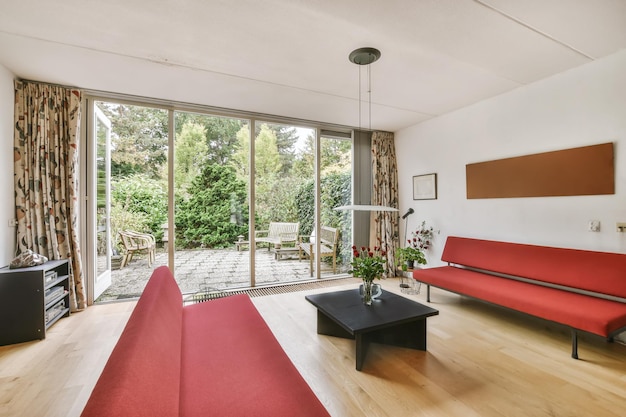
xmin=97 ymin=102 xmax=351 ymax=258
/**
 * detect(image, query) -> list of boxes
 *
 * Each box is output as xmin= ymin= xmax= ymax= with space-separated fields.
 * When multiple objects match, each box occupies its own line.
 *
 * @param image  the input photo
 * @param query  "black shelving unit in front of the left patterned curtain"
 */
xmin=0 ymin=259 xmax=70 ymax=345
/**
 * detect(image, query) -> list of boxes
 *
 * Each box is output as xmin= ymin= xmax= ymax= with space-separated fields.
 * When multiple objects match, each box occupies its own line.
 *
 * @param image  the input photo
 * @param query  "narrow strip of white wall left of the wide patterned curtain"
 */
xmin=0 ymin=65 xmax=15 ymax=266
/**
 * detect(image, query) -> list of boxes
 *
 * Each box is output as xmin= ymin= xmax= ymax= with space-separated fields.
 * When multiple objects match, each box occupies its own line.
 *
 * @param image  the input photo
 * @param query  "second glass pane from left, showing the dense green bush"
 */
xmin=170 ymin=111 xmax=250 ymax=293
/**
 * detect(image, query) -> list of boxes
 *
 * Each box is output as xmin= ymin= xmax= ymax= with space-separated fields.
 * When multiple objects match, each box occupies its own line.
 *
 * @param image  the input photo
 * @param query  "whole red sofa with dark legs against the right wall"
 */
xmin=413 ymin=236 xmax=626 ymax=358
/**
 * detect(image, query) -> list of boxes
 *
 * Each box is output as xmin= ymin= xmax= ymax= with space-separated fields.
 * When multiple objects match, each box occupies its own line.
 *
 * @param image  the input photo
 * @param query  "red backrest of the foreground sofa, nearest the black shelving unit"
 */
xmin=81 ymin=266 xmax=183 ymax=417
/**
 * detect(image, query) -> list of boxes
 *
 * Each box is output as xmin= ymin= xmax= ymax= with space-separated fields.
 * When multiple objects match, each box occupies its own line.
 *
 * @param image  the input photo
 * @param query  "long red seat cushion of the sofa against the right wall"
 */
xmin=413 ymin=266 xmax=626 ymax=337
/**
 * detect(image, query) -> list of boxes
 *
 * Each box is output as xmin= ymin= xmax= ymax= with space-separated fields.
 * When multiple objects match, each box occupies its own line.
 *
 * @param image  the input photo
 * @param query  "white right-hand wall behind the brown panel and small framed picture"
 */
xmin=395 ymin=50 xmax=626 ymax=266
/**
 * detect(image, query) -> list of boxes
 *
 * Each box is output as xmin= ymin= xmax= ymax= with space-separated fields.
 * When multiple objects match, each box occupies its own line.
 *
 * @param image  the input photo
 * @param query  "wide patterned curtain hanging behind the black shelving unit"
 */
xmin=14 ymin=81 xmax=86 ymax=311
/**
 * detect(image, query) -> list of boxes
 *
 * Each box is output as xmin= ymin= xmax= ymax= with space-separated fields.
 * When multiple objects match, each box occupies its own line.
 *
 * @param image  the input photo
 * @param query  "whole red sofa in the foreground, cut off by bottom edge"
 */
xmin=82 ymin=267 xmax=329 ymax=417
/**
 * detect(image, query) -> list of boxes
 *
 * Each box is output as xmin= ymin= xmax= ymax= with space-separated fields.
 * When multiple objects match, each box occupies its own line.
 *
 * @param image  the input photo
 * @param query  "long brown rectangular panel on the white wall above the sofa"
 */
xmin=466 ymin=143 xmax=615 ymax=199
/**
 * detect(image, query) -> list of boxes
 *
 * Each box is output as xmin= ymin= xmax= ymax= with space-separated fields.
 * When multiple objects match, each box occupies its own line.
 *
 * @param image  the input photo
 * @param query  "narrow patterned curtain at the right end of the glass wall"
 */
xmin=372 ymin=132 xmax=399 ymax=277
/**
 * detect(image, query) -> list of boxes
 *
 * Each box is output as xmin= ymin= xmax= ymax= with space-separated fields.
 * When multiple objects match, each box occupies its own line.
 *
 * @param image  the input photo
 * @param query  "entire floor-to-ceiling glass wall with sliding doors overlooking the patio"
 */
xmin=86 ymin=96 xmax=352 ymax=301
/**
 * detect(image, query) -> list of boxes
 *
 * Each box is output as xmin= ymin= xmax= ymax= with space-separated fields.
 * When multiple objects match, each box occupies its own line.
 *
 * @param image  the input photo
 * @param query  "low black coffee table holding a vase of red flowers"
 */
xmin=305 ymin=289 xmax=439 ymax=371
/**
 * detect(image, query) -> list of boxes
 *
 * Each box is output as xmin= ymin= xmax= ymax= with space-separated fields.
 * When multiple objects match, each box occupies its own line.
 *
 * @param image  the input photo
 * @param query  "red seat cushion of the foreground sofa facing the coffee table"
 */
xmin=180 ymin=295 xmax=328 ymax=417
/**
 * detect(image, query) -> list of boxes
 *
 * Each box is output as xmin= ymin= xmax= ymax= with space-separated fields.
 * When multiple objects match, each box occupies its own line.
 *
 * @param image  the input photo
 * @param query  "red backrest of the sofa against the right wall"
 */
xmin=441 ymin=236 xmax=626 ymax=299
